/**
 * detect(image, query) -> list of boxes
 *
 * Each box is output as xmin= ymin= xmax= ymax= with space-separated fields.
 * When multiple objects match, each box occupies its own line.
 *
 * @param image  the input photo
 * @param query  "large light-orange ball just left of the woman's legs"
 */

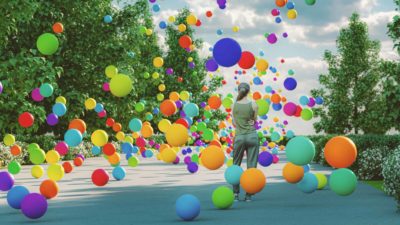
xmin=200 ymin=145 xmax=225 ymax=170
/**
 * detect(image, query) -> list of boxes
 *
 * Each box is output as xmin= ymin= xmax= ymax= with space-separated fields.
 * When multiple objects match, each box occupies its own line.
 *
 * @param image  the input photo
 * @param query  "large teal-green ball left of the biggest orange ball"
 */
xmin=286 ymin=136 xmax=315 ymax=166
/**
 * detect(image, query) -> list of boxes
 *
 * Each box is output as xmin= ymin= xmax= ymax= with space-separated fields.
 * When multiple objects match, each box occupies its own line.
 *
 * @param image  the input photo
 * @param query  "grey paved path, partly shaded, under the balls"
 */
xmin=0 ymin=152 xmax=400 ymax=225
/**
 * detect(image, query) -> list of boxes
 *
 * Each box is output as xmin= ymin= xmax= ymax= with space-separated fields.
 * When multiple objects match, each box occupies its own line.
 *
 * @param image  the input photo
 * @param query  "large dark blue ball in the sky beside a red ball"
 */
xmin=213 ymin=38 xmax=242 ymax=67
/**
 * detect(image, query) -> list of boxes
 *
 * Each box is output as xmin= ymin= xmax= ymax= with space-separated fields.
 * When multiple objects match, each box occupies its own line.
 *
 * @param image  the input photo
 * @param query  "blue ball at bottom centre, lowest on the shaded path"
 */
xmin=175 ymin=194 xmax=200 ymax=221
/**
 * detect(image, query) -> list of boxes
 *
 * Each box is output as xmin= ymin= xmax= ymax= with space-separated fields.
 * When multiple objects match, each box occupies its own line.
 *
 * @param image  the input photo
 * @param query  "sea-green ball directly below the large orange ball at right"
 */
xmin=329 ymin=168 xmax=357 ymax=196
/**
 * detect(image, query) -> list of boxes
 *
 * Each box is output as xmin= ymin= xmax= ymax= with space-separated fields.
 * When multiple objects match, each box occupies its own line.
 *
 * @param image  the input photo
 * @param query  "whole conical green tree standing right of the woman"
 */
xmin=312 ymin=13 xmax=390 ymax=134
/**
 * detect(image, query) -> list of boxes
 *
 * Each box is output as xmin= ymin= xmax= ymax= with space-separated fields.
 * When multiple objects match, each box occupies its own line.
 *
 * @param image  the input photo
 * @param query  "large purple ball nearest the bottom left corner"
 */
xmin=21 ymin=193 xmax=47 ymax=219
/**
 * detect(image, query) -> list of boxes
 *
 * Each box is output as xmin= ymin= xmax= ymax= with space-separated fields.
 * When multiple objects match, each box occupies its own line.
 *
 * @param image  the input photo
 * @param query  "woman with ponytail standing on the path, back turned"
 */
xmin=232 ymin=83 xmax=260 ymax=202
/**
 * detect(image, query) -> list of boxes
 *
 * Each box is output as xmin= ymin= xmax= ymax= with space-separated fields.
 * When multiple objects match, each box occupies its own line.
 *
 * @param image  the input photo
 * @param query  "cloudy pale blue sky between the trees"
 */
xmin=120 ymin=0 xmax=399 ymax=134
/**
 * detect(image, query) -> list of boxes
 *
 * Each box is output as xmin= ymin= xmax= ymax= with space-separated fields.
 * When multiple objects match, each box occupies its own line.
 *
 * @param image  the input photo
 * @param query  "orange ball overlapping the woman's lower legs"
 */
xmin=240 ymin=168 xmax=266 ymax=194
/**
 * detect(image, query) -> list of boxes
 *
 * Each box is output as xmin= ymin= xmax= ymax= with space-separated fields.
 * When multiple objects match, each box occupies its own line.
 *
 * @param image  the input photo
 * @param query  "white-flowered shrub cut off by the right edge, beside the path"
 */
xmin=382 ymin=146 xmax=400 ymax=209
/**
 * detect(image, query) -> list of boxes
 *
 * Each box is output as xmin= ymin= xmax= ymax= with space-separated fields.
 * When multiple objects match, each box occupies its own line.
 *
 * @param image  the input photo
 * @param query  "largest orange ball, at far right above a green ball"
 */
xmin=324 ymin=136 xmax=357 ymax=168
